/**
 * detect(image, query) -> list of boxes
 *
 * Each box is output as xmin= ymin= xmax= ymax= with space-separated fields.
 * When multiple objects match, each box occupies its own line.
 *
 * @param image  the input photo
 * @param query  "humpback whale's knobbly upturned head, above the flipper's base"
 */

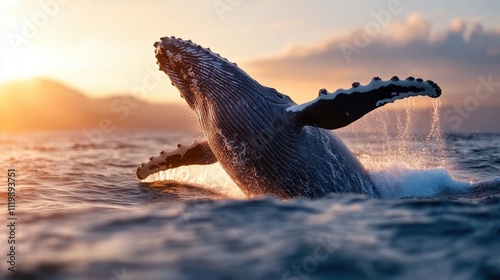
xmin=154 ymin=37 xmax=291 ymax=110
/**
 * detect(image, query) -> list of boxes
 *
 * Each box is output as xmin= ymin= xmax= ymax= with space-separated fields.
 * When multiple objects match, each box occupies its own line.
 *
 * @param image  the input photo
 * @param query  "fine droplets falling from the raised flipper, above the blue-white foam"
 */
xmin=344 ymin=99 xmax=449 ymax=171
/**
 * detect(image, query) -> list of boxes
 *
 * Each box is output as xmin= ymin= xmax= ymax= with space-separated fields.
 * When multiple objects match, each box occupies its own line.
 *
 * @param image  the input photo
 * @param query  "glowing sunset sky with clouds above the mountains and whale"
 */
xmin=0 ymin=0 xmax=500 ymax=107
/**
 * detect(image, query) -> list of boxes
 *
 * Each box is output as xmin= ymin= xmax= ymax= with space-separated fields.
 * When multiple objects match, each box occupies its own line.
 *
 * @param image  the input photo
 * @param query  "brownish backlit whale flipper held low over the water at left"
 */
xmin=136 ymin=141 xmax=217 ymax=180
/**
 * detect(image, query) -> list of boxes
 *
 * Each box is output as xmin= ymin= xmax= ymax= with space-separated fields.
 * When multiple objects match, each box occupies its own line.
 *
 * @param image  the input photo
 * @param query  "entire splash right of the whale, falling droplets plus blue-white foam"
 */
xmin=347 ymin=100 xmax=471 ymax=199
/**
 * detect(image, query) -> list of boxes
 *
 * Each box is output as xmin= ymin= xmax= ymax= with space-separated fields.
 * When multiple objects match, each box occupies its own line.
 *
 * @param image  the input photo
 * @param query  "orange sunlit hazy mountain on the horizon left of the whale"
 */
xmin=0 ymin=78 xmax=198 ymax=132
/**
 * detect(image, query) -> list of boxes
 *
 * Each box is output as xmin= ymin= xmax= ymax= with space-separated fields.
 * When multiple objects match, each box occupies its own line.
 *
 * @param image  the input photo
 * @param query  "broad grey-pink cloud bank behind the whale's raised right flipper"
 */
xmin=246 ymin=14 xmax=500 ymax=105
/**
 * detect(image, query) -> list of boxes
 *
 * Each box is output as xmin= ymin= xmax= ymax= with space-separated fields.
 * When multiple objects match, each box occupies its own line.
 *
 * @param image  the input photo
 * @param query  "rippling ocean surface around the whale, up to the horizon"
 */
xmin=0 ymin=131 xmax=500 ymax=280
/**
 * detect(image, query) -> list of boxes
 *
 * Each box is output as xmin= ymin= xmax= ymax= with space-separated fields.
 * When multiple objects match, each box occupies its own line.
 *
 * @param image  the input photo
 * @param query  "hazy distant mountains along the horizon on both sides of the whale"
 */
xmin=0 ymin=78 xmax=500 ymax=132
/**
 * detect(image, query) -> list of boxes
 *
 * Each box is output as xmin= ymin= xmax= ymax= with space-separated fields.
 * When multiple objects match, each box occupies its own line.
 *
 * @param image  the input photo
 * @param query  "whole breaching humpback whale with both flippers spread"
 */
xmin=136 ymin=37 xmax=441 ymax=199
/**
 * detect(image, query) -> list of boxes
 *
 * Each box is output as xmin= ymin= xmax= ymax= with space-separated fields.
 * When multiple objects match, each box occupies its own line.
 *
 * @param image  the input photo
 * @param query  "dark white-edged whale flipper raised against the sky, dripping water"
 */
xmin=286 ymin=76 xmax=441 ymax=129
